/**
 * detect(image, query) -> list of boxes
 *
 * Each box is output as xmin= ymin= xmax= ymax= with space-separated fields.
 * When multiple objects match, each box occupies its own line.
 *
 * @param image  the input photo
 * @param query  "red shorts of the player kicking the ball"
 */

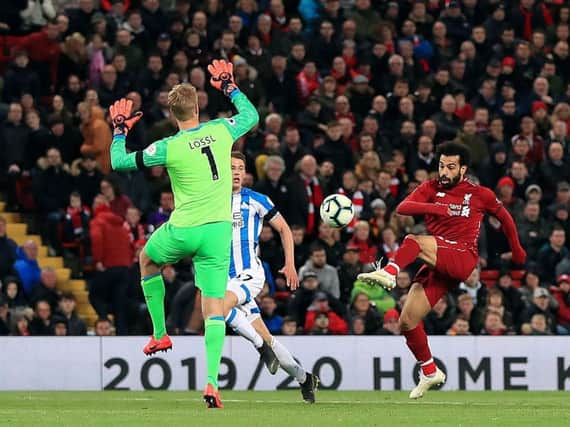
xmin=412 ymin=236 xmax=478 ymax=307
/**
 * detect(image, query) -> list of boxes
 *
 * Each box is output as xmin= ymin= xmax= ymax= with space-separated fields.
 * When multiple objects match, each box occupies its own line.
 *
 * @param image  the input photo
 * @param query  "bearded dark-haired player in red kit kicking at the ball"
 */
xmin=358 ymin=142 xmax=526 ymax=399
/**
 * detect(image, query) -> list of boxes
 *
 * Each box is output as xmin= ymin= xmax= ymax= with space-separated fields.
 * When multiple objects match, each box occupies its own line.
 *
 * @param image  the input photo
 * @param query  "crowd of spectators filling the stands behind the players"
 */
xmin=0 ymin=0 xmax=570 ymax=335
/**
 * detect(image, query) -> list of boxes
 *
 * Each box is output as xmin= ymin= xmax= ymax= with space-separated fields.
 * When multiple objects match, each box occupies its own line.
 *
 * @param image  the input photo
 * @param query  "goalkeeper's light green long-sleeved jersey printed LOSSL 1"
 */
xmin=111 ymin=91 xmax=259 ymax=227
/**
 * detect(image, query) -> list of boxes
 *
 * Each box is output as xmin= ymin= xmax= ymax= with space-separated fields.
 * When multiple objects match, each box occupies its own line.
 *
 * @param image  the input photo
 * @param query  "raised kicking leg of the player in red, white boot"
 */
xmin=358 ymin=234 xmax=437 ymax=290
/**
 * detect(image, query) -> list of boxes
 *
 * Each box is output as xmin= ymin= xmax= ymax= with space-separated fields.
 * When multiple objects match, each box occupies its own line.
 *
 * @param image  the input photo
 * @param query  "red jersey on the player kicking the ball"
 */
xmin=406 ymin=179 xmax=502 ymax=252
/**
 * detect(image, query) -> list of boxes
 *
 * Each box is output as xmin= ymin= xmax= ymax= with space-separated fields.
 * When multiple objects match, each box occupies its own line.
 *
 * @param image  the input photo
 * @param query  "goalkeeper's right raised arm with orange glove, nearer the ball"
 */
xmin=208 ymin=59 xmax=259 ymax=141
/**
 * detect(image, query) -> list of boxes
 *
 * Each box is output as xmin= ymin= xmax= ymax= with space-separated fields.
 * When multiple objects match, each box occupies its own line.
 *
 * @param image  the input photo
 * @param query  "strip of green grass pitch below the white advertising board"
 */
xmin=0 ymin=390 xmax=570 ymax=427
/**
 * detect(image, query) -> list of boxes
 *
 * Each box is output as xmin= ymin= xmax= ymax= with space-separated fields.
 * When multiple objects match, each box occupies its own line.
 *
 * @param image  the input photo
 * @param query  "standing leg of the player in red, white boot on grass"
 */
xmin=399 ymin=283 xmax=445 ymax=399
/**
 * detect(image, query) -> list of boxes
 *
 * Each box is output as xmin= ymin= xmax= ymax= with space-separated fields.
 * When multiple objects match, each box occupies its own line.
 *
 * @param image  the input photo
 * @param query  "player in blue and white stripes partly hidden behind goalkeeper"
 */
xmin=224 ymin=152 xmax=319 ymax=403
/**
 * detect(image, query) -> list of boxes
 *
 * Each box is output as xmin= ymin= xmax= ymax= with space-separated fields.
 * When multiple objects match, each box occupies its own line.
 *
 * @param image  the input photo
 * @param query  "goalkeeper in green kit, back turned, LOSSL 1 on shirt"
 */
xmin=110 ymin=60 xmax=259 ymax=408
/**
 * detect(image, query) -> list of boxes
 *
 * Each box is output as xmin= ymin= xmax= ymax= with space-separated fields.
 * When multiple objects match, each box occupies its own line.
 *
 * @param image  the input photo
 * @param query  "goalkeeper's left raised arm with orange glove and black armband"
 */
xmin=109 ymin=98 xmax=166 ymax=171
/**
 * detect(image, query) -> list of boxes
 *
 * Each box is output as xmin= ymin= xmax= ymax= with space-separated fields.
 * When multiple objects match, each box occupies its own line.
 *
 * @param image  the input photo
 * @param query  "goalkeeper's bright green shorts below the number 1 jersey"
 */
xmin=144 ymin=221 xmax=232 ymax=298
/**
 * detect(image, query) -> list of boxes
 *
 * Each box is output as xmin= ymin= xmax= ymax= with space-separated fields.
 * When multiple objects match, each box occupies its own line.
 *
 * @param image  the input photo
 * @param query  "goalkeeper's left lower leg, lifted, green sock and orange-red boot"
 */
xmin=140 ymin=249 xmax=172 ymax=356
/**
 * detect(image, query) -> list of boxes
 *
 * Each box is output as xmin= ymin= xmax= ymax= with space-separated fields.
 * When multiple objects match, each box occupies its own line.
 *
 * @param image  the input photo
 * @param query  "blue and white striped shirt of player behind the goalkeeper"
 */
xmin=230 ymin=188 xmax=278 ymax=279
